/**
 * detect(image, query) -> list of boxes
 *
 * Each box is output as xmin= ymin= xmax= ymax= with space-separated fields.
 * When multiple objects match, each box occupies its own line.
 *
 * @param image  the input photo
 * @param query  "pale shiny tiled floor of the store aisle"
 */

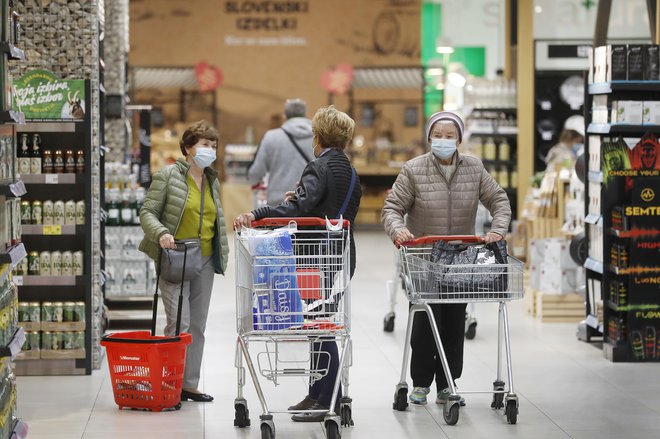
xmin=18 ymin=232 xmax=660 ymax=439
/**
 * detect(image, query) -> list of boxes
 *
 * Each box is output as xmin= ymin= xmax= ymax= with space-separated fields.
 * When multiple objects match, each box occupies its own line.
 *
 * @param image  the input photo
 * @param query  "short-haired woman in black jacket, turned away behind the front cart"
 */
xmin=234 ymin=105 xmax=362 ymax=422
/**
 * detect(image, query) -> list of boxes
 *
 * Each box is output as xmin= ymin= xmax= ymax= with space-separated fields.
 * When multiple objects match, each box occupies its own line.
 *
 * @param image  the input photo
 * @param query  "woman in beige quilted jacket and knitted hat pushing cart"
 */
xmin=381 ymin=111 xmax=511 ymax=404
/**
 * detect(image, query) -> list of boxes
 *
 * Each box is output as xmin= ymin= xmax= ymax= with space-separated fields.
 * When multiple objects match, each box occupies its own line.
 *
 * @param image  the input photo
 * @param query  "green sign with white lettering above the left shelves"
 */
xmin=14 ymin=70 xmax=85 ymax=120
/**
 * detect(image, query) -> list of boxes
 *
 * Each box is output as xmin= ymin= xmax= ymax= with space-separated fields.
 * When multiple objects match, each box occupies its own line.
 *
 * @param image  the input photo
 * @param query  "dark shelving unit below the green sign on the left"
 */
xmin=15 ymin=80 xmax=97 ymax=375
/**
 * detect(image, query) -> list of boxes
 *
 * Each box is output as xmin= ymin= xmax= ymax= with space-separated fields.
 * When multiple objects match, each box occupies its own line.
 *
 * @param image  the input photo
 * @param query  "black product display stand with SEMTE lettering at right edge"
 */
xmin=578 ymin=79 xmax=660 ymax=361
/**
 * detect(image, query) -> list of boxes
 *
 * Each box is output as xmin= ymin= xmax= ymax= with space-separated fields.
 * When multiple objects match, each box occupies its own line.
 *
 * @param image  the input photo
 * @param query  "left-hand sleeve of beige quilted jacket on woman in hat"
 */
xmin=380 ymin=165 xmax=415 ymax=241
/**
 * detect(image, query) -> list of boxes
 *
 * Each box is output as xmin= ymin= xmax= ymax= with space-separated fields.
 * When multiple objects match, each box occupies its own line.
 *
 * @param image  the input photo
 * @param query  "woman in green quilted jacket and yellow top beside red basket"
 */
xmin=140 ymin=121 xmax=229 ymax=402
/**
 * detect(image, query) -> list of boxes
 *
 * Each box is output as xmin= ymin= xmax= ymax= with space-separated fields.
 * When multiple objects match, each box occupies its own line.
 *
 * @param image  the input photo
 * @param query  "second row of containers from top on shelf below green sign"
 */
xmin=21 ymin=200 xmax=86 ymax=225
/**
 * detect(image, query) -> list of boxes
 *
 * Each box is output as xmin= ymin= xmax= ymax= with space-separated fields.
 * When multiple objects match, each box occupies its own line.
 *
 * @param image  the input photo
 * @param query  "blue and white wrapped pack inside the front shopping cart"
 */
xmin=248 ymin=230 xmax=303 ymax=330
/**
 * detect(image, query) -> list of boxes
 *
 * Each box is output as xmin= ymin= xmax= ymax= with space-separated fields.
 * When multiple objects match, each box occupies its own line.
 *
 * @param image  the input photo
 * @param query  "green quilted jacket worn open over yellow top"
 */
xmin=140 ymin=158 xmax=229 ymax=274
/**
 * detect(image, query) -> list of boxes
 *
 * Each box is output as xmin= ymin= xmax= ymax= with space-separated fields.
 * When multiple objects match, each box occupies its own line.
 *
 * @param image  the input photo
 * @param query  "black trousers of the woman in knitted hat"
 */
xmin=410 ymin=303 xmax=467 ymax=392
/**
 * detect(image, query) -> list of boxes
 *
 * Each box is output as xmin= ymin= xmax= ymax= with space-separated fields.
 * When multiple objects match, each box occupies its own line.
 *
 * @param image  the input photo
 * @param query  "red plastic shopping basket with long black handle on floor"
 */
xmin=101 ymin=244 xmax=192 ymax=412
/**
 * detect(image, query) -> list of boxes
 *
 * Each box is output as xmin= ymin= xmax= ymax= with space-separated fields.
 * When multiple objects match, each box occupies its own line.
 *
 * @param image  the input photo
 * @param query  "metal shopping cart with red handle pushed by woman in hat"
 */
xmin=393 ymin=236 xmax=524 ymax=425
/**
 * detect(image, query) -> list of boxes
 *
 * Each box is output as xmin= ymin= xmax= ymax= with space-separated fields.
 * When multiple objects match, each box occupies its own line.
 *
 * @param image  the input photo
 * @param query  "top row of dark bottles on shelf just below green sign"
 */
xmin=16 ymin=133 xmax=85 ymax=175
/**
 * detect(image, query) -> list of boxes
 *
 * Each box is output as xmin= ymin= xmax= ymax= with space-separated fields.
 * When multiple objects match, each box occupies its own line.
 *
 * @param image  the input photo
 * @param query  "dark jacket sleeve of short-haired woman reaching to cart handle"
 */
xmin=252 ymin=161 xmax=328 ymax=220
